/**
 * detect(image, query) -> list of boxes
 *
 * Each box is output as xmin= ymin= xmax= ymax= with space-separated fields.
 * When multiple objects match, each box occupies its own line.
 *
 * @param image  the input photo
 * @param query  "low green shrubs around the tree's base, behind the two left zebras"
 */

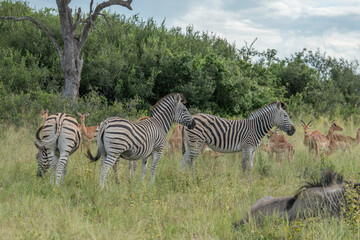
xmin=0 ymin=89 xmax=145 ymax=127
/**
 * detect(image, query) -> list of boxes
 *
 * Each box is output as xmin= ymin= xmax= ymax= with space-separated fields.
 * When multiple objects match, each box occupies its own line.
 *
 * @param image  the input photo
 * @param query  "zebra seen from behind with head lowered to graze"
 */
xmin=35 ymin=113 xmax=81 ymax=185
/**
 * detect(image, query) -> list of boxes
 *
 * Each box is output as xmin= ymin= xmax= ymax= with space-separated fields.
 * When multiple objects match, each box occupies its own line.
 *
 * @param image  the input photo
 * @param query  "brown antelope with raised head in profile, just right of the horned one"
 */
xmin=309 ymin=120 xmax=343 ymax=161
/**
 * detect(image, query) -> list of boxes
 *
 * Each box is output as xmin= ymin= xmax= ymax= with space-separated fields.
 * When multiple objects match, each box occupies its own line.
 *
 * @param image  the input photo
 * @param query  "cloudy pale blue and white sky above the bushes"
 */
xmin=28 ymin=0 xmax=360 ymax=60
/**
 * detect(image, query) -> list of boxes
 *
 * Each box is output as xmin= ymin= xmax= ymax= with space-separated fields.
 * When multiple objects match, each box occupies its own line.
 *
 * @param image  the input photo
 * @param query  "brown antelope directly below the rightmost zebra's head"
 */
xmin=268 ymin=129 xmax=295 ymax=162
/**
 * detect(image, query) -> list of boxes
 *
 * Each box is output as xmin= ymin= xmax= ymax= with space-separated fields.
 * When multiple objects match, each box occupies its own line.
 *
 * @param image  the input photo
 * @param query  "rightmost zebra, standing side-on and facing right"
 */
xmin=182 ymin=102 xmax=295 ymax=181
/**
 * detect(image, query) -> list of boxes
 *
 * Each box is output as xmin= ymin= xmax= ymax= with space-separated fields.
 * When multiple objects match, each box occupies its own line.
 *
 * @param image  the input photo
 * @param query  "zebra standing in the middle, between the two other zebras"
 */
xmin=87 ymin=93 xmax=195 ymax=187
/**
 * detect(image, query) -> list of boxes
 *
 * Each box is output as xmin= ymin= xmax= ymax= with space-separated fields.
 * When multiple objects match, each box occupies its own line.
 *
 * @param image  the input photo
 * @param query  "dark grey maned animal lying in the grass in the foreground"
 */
xmin=234 ymin=171 xmax=360 ymax=227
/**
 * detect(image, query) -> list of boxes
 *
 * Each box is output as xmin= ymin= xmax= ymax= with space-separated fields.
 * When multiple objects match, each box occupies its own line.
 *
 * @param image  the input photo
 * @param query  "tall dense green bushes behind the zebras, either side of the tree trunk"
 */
xmin=0 ymin=0 xmax=360 ymax=121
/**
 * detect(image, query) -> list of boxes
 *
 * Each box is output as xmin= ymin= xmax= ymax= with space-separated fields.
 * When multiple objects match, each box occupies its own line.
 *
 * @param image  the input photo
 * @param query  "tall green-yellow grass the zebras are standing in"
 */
xmin=0 ymin=119 xmax=360 ymax=239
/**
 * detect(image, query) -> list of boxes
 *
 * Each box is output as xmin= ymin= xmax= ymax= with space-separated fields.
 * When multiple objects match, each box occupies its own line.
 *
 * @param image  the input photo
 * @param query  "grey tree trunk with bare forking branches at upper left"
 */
xmin=0 ymin=0 xmax=132 ymax=99
